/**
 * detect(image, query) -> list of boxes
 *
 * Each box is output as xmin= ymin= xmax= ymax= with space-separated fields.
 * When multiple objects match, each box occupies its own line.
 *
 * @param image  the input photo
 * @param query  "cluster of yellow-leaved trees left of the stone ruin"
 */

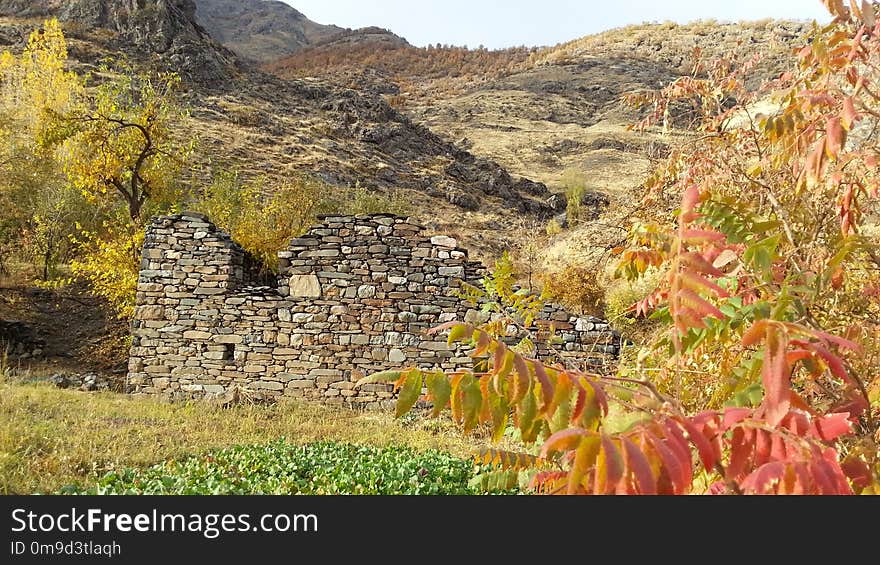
xmin=0 ymin=20 xmax=194 ymax=317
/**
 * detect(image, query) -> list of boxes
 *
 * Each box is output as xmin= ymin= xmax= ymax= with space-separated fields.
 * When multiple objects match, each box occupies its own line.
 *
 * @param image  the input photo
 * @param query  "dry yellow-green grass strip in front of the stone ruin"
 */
xmin=0 ymin=379 xmax=496 ymax=494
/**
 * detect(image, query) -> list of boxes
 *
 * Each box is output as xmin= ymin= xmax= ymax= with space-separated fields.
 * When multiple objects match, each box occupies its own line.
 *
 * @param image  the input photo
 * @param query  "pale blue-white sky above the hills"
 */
xmin=284 ymin=0 xmax=830 ymax=49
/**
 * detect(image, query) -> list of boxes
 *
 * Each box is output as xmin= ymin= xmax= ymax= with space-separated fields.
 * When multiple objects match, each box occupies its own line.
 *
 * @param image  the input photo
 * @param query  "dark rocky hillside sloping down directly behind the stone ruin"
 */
xmin=0 ymin=0 xmax=560 ymax=254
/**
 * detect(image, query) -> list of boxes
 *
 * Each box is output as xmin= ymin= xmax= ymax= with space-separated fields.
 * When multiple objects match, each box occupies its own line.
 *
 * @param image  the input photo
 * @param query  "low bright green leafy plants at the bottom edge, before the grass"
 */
xmin=60 ymin=440 xmax=508 ymax=495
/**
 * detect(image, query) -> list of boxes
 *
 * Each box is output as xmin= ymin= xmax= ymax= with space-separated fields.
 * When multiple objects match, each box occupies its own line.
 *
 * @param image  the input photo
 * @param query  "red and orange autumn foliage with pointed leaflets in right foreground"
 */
xmin=372 ymin=0 xmax=880 ymax=494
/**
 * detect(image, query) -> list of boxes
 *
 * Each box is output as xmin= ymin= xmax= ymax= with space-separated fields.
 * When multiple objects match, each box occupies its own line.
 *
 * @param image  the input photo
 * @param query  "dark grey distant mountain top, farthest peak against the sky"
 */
xmin=195 ymin=0 xmax=406 ymax=63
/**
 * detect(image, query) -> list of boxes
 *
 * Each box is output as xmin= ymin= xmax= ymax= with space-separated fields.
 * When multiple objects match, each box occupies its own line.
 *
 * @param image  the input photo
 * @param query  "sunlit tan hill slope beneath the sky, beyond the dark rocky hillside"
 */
xmin=265 ymin=15 xmax=808 ymax=263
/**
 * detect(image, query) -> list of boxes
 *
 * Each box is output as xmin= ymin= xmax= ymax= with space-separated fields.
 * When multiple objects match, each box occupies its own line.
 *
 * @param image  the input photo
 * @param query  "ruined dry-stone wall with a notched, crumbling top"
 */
xmin=128 ymin=212 xmax=619 ymax=408
